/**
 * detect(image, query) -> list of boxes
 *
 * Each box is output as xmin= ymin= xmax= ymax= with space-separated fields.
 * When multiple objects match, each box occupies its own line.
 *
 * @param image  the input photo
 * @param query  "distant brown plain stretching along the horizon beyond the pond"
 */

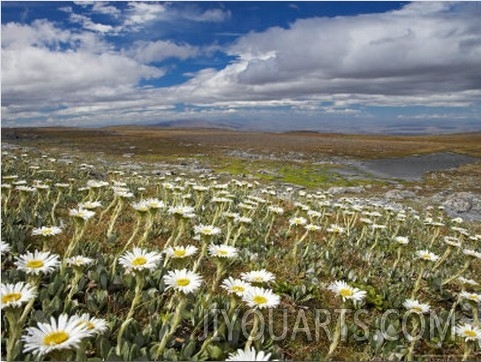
xmin=2 ymin=127 xmax=481 ymax=158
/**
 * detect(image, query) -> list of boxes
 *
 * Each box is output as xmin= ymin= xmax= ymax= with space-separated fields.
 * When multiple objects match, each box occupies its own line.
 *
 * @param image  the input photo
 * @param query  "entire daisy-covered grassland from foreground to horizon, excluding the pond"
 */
xmin=1 ymin=128 xmax=481 ymax=361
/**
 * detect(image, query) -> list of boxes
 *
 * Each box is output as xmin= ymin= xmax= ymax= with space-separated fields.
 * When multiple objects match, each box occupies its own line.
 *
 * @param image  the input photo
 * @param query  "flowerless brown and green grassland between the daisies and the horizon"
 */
xmin=2 ymin=127 xmax=481 ymax=190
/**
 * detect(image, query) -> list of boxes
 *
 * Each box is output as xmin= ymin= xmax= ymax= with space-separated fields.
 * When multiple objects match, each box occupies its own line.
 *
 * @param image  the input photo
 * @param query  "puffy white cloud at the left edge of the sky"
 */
xmin=2 ymin=21 xmax=163 ymax=108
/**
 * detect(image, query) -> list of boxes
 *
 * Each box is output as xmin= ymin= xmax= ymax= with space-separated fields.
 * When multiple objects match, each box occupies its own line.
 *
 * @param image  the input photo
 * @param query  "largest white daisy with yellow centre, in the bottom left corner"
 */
xmin=22 ymin=314 xmax=90 ymax=356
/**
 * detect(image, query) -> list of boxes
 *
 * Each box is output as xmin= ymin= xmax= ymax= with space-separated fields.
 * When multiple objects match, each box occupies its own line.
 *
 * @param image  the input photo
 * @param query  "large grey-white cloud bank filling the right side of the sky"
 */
xmin=177 ymin=2 xmax=481 ymax=103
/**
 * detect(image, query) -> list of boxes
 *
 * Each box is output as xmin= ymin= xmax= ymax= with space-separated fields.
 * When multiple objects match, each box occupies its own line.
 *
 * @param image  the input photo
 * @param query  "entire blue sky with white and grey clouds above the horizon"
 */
xmin=1 ymin=1 xmax=481 ymax=133
